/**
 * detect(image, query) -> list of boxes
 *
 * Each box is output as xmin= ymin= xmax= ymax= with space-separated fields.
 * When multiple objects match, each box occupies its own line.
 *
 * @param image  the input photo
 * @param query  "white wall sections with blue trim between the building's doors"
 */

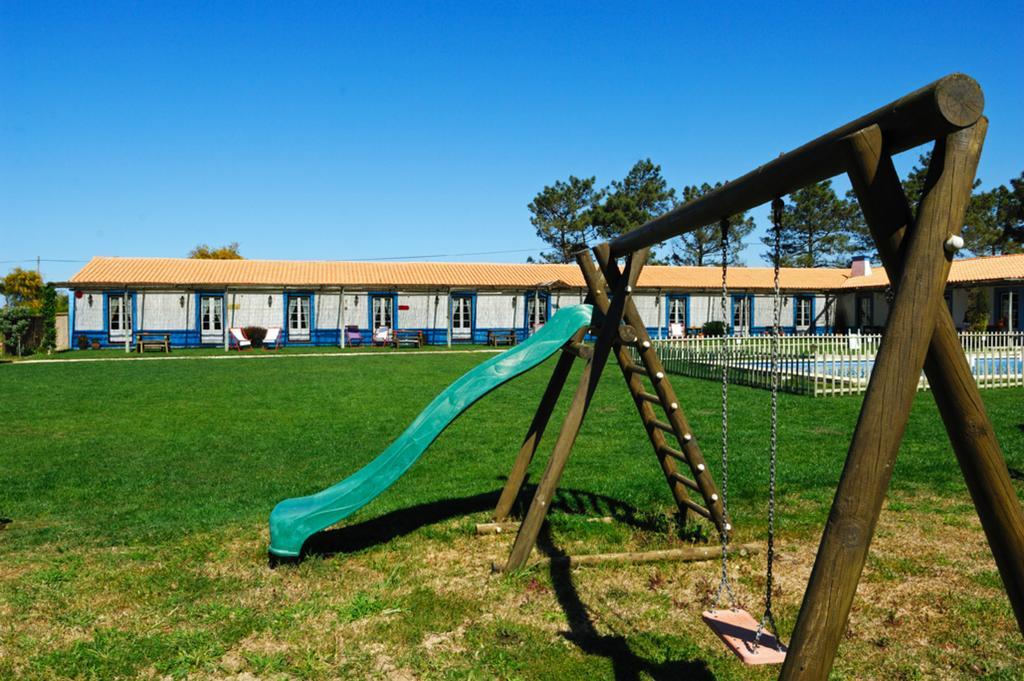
xmin=70 ymin=280 xmax=1024 ymax=347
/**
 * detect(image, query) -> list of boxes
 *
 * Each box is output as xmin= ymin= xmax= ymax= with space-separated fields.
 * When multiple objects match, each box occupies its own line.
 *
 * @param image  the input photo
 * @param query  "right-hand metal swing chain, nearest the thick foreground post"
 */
xmin=754 ymin=199 xmax=784 ymax=650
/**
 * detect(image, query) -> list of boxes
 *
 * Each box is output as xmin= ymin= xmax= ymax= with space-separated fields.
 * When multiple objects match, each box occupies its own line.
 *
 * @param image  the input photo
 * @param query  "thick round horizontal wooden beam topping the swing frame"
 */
xmin=609 ymin=74 xmax=985 ymax=257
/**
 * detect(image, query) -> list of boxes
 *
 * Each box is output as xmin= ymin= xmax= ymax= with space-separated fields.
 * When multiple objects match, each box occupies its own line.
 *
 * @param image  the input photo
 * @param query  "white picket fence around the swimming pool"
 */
xmin=654 ymin=332 xmax=1024 ymax=395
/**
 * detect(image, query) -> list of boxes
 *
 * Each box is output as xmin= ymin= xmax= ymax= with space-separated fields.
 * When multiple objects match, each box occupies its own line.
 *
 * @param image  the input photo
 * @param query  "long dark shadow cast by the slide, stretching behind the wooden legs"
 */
xmin=270 ymin=485 xmax=684 ymax=567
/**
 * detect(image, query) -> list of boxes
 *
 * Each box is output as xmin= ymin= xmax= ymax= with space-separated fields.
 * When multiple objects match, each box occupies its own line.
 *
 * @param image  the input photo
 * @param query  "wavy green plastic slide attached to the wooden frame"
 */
xmin=270 ymin=305 xmax=592 ymax=558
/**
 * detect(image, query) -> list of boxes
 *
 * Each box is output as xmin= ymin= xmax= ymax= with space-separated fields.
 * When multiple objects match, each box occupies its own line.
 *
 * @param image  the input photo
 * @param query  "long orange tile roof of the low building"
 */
xmin=61 ymin=254 xmax=1024 ymax=291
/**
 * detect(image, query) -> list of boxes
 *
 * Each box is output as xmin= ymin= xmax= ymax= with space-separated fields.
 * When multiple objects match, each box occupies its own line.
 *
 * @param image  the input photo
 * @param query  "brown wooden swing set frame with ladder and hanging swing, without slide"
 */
xmin=485 ymin=74 xmax=1024 ymax=679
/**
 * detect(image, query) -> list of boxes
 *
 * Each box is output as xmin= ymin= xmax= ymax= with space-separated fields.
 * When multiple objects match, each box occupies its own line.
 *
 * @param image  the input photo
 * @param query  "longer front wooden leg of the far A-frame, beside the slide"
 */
xmin=505 ymin=249 xmax=647 ymax=570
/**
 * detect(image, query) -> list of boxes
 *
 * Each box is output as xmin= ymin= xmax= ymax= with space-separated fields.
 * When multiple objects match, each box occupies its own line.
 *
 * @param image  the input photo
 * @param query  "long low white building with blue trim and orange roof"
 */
xmin=59 ymin=255 xmax=1024 ymax=347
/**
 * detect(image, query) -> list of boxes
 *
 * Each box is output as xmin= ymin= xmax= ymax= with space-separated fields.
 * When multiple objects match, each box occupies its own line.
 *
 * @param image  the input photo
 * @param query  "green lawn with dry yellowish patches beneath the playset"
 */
xmin=0 ymin=352 xmax=1024 ymax=679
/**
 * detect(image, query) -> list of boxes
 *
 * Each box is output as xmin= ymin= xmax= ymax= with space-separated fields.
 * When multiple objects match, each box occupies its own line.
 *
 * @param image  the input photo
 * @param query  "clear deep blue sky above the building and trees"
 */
xmin=0 ymin=0 xmax=1024 ymax=280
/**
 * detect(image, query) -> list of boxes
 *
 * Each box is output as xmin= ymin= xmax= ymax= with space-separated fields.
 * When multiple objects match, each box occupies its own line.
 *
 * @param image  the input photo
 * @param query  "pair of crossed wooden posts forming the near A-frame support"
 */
xmin=780 ymin=118 xmax=1024 ymax=679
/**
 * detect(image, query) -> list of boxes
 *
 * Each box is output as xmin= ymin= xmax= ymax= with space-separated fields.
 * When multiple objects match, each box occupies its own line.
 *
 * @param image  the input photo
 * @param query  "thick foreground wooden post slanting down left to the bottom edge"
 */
xmin=780 ymin=124 xmax=985 ymax=680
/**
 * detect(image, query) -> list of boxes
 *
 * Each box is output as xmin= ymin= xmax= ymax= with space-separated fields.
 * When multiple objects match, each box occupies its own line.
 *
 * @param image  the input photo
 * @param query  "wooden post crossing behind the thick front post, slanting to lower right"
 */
xmin=848 ymin=119 xmax=1024 ymax=633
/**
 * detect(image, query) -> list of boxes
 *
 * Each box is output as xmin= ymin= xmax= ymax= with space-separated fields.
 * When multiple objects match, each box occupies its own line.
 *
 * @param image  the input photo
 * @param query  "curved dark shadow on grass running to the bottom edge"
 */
xmin=537 ymin=525 xmax=715 ymax=681
